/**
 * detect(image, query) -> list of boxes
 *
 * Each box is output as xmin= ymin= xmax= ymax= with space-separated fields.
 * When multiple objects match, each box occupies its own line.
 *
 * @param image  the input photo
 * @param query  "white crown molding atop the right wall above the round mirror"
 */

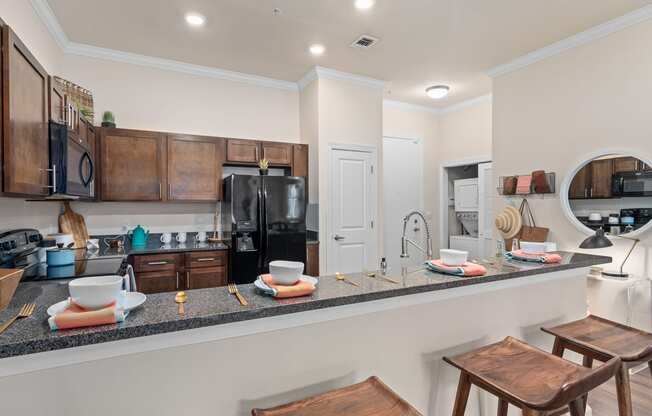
xmin=487 ymin=5 xmax=652 ymax=78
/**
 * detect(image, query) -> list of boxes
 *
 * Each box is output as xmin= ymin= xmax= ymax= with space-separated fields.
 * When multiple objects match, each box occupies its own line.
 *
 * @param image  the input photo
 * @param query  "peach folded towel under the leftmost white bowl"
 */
xmin=48 ymin=300 xmax=126 ymax=331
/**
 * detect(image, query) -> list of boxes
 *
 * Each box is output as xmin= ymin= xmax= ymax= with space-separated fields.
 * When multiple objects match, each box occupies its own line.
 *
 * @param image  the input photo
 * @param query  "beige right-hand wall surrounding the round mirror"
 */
xmin=493 ymin=21 xmax=652 ymax=276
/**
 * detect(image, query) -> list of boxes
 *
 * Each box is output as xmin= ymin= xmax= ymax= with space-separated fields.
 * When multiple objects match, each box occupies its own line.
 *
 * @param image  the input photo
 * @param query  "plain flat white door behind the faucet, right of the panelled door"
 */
xmin=383 ymin=137 xmax=425 ymax=265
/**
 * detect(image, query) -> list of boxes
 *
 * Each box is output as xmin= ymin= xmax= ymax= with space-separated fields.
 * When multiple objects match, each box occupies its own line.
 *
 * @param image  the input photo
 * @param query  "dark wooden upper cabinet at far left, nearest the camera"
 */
xmin=1 ymin=26 xmax=50 ymax=196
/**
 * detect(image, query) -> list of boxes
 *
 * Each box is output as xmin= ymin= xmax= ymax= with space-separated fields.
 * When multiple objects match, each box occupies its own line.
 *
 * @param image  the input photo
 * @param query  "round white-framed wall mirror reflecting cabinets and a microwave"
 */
xmin=561 ymin=152 xmax=652 ymax=236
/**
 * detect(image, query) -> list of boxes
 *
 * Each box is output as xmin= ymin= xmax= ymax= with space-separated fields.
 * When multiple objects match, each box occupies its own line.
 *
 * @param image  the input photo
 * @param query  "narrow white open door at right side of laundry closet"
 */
xmin=478 ymin=163 xmax=496 ymax=259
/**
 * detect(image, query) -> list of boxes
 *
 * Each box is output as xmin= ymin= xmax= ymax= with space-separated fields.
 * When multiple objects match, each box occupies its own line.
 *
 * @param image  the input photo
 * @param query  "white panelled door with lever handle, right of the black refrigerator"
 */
xmin=327 ymin=148 xmax=378 ymax=274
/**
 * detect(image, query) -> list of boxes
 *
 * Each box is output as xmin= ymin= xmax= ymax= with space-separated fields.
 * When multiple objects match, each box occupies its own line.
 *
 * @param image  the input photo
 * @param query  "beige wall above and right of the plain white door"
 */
xmin=383 ymin=101 xmax=442 ymax=250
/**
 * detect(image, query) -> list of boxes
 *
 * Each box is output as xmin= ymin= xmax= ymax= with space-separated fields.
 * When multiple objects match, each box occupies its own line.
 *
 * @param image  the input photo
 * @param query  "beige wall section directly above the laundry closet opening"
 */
xmin=438 ymin=97 xmax=492 ymax=162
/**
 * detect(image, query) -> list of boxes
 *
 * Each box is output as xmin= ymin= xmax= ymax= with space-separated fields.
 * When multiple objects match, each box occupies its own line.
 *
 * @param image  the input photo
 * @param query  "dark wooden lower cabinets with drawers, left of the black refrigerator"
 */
xmin=130 ymin=250 xmax=228 ymax=294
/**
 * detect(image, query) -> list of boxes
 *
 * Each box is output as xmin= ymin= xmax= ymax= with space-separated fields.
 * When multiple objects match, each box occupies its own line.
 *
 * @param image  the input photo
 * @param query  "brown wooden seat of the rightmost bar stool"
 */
xmin=542 ymin=315 xmax=652 ymax=361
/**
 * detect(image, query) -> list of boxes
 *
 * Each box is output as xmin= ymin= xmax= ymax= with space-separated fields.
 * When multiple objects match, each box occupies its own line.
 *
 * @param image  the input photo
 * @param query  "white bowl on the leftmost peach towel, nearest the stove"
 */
xmin=68 ymin=276 xmax=123 ymax=309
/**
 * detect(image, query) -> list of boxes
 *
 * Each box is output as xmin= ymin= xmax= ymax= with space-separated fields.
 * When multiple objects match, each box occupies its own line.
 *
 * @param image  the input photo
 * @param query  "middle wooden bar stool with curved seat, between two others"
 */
xmin=444 ymin=337 xmax=620 ymax=416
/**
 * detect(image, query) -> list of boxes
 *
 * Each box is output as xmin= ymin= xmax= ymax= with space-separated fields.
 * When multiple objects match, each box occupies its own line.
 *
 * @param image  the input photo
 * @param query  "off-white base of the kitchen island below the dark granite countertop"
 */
xmin=0 ymin=268 xmax=587 ymax=416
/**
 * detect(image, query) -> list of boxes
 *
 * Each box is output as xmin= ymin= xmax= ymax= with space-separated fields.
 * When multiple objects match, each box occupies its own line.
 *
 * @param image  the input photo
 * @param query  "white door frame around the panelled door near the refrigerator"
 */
xmin=328 ymin=143 xmax=383 ymax=274
